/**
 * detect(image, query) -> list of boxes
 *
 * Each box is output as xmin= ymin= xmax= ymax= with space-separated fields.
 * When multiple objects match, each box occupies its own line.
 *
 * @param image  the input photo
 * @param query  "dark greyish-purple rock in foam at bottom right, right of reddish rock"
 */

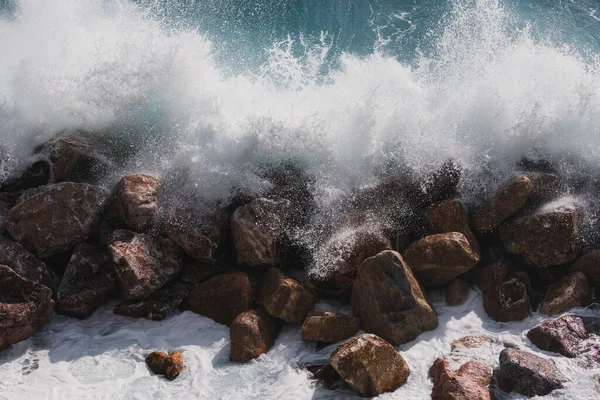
xmin=497 ymin=348 xmax=567 ymax=397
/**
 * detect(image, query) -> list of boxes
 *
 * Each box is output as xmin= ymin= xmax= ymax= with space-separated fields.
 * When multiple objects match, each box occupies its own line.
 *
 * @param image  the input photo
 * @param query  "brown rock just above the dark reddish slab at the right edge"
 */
xmin=540 ymin=272 xmax=592 ymax=315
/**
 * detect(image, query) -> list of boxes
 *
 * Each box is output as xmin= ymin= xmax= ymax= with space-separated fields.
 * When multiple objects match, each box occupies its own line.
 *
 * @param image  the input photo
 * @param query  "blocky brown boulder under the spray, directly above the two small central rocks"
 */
xmin=231 ymin=198 xmax=293 ymax=266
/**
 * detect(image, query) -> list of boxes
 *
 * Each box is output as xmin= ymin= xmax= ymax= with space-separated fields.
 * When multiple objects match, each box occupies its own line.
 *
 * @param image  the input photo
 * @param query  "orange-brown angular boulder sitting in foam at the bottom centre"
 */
xmin=329 ymin=333 xmax=410 ymax=397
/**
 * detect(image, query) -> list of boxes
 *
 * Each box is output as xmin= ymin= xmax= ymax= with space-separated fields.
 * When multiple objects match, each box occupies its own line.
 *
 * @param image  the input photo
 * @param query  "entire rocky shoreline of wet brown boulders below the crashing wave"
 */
xmin=0 ymin=134 xmax=600 ymax=399
